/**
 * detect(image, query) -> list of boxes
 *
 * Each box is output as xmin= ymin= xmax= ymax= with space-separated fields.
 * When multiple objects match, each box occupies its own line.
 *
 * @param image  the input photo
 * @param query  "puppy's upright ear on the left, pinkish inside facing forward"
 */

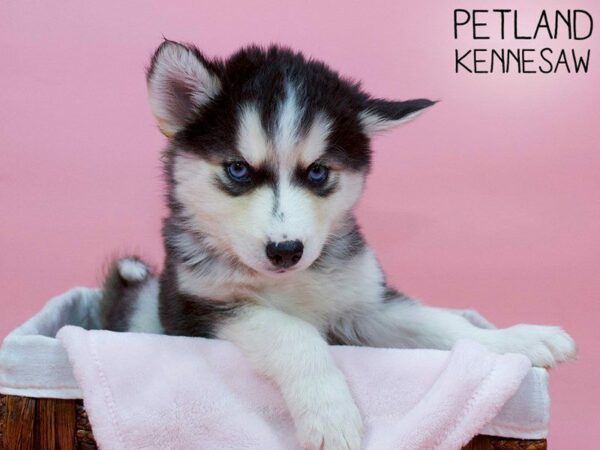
xmin=146 ymin=40 xmax=221 ymax=137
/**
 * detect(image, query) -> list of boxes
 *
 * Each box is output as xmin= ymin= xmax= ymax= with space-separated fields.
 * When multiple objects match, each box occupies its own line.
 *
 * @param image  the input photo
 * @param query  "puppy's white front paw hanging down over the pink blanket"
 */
xmin=295 ymin=374 xmax=362 ymax=450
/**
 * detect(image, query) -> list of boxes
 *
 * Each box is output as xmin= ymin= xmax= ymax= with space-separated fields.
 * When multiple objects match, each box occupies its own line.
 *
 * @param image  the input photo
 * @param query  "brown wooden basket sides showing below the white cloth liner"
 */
xmin=0 ymin=395 xmax=547 ymax=450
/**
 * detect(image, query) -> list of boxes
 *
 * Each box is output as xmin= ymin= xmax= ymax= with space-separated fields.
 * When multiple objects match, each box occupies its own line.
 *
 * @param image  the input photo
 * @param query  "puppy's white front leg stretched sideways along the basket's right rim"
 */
xmin=332 ymin=296 xmax=576 ymax=367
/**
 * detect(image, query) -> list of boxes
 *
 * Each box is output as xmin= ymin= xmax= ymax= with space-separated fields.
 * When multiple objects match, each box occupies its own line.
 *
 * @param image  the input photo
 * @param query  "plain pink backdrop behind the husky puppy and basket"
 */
xmin=0 ymin=0 xmax=600 ymax=442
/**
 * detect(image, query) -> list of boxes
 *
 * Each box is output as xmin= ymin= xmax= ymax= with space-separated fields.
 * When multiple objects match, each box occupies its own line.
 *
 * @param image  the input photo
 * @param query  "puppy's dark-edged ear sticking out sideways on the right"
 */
xmin=359 ymin=98 xmax=436 ymax=136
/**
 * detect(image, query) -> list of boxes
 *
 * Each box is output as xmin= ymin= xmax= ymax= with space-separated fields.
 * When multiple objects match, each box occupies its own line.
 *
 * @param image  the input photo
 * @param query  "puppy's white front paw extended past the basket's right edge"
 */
xmin=492 ymin=324 xmax=577 ymax=367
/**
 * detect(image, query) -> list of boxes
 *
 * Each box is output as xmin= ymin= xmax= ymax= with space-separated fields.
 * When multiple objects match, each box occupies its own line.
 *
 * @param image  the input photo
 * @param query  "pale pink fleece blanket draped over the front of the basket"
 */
xmin=57 ymin=326 xmax=530 ymax=450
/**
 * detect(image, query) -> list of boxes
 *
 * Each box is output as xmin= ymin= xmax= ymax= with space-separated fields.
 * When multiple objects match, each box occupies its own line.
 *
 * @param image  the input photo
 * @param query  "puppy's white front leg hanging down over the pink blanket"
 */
xmin=217 ymin=306 xmax=362 ymax=450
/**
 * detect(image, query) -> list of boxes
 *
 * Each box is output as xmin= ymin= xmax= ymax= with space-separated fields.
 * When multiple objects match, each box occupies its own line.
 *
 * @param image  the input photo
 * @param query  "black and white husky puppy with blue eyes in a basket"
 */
xmin=104 ymin=40 xmax=575 ymax=449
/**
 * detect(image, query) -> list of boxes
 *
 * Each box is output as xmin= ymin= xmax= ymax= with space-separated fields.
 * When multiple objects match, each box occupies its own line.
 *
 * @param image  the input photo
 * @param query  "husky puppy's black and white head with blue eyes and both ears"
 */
xmin=148 ymin=41 xmax=433 ymax=274
